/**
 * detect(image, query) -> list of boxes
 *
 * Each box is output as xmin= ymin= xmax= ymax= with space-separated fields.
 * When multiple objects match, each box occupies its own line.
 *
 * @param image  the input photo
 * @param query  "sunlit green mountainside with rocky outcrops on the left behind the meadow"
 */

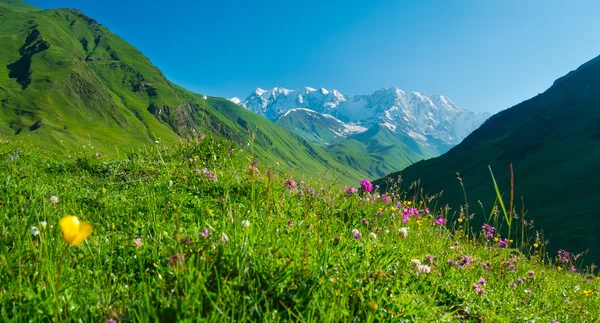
xmin=0 ymin=0 xmax=360 ymax=185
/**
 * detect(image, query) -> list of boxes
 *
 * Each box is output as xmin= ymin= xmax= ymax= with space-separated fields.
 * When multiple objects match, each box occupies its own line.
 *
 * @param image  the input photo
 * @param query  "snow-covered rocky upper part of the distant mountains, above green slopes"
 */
xmin=232 ymin=87 xmax=489 ymax=153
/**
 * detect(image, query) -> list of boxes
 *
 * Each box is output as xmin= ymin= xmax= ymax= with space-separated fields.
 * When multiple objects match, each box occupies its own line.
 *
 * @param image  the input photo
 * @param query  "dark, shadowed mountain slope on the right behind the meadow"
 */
xmin=379 ymin=53 xmax=600 ymax=263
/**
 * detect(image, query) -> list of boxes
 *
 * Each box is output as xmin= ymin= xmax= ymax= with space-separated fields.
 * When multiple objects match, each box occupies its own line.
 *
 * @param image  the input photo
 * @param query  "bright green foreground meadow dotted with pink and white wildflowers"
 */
xmin=0 ymin=136 xmax=600 ymax=322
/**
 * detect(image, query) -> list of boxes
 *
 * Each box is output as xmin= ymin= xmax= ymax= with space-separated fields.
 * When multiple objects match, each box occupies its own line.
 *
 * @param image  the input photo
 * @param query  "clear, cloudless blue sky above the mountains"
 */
xmin=26 ymin=0 xmax=600 ymax=112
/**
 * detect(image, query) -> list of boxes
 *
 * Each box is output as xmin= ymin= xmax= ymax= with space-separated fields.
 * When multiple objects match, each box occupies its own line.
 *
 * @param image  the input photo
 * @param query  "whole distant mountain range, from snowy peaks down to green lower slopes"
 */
xmin=230 ymin=87 xmax=489 ymax=177
